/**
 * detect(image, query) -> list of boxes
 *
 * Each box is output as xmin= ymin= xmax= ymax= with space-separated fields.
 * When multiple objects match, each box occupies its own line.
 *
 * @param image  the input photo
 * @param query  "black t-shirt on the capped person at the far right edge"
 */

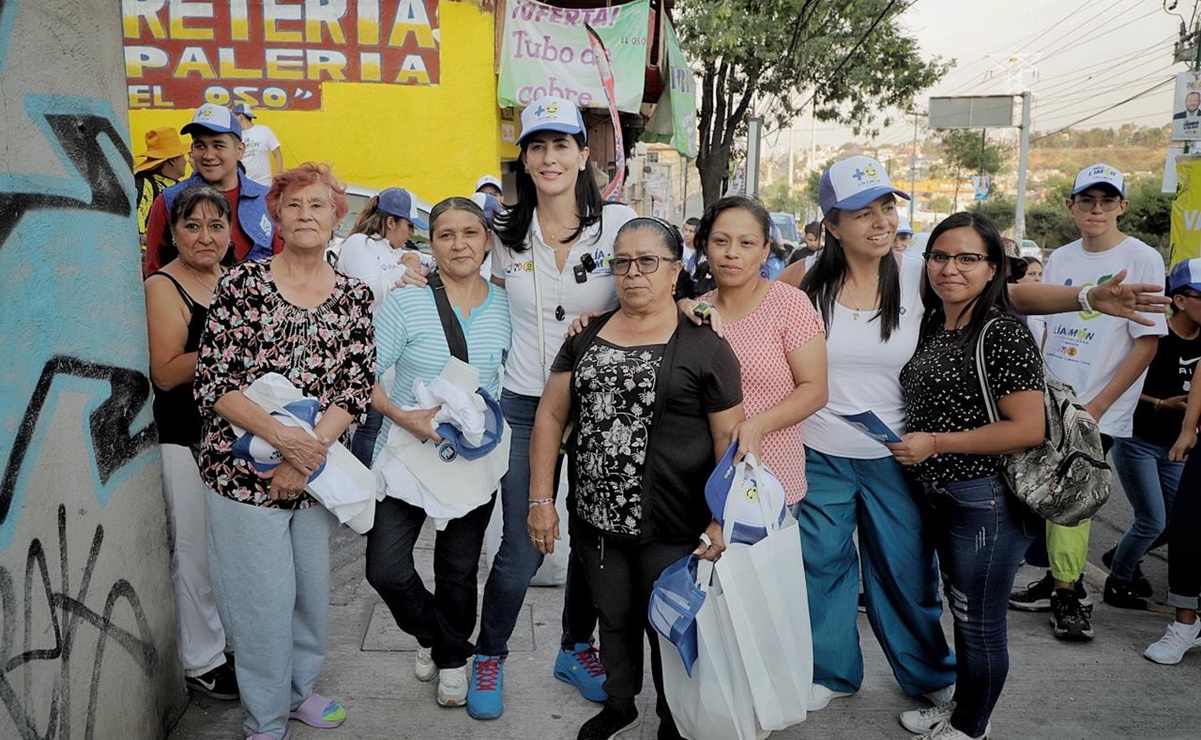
xmin=1134 ymin=324 xmax=1201 ymax=446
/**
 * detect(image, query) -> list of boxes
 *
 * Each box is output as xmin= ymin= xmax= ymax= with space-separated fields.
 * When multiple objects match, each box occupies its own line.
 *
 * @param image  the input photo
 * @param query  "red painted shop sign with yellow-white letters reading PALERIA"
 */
xmin=121 ymin=0 xmax=441 ymax=111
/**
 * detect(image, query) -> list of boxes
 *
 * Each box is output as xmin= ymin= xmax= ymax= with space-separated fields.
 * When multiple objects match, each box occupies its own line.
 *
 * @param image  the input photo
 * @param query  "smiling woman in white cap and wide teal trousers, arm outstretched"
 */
xmin=781 ymin=156 xmax=1161 ymax=730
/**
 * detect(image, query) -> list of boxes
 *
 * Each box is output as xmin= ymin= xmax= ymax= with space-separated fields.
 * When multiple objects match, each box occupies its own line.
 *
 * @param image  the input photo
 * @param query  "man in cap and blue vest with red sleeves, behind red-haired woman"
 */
xmin=144 ymin=103 xmax=283 ymax=276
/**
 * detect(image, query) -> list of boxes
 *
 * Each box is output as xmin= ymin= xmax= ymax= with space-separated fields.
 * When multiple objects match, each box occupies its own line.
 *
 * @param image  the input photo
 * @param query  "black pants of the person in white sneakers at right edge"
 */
xmin=1167 ymin=448 xmax=1201 ymax=610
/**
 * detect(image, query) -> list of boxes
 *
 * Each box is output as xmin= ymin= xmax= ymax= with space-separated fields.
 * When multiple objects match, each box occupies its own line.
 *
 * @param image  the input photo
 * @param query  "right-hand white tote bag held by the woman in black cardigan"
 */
xmin=716 ymin=460 xmax=813 ymax=730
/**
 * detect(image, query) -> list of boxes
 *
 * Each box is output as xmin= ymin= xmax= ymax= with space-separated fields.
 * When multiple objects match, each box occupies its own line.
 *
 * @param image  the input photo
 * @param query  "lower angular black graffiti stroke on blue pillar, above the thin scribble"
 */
xmin=0 ymin=356 xmax=159 ymax=525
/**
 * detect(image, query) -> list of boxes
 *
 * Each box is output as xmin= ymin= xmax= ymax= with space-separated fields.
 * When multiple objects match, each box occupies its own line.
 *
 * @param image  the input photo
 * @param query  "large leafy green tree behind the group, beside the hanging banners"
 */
xmin=674 ymin=0 xmax=950 ymax=204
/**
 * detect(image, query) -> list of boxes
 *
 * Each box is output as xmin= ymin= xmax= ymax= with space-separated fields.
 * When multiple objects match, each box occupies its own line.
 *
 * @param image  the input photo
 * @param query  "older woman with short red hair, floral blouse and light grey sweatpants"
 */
xmin=196 ymin=163 xmax=375 ymax=740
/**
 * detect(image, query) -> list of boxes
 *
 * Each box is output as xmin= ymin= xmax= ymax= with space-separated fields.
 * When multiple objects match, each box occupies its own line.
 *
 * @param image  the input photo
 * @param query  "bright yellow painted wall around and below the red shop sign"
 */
xmin=126 ymin=0 xmax=504 ymax=203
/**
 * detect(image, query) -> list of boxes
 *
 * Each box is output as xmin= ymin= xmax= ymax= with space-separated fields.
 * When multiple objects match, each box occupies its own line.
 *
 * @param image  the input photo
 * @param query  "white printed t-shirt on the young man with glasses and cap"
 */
xmin=1042 ymin=237 xmax=1167 ymax=437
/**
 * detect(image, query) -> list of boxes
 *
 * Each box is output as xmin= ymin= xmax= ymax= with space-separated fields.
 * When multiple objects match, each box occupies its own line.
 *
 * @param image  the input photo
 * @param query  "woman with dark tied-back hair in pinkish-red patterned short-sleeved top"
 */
xmin=697 ymin=196 xmax=826 ymax=506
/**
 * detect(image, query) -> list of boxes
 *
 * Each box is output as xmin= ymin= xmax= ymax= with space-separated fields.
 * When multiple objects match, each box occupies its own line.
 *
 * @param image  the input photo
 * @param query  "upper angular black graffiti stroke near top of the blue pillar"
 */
xmin=0 ymin=112 xmax=132 ymax=243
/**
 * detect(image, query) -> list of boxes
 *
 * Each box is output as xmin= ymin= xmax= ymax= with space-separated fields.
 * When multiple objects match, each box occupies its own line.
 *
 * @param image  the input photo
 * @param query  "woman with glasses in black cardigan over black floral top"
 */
xmin=527 ymin=219 xmax=743 ymax=740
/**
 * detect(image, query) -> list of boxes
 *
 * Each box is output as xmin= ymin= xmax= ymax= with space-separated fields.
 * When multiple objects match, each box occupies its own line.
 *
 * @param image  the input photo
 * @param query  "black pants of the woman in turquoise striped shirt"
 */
xmin=368 ymin=496 xmax=496 ymax=668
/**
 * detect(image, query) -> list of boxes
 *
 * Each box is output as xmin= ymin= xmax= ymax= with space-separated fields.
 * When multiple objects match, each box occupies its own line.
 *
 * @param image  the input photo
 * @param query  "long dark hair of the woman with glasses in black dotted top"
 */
xmin=921 ymin=211 xmax=1014 ymax=358
